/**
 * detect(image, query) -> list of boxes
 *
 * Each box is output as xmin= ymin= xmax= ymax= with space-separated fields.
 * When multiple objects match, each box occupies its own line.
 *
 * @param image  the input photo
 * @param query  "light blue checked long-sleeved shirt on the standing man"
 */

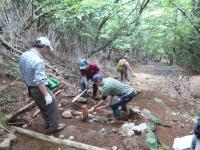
xmin=20 ymin=48 xmax=48 ymax=86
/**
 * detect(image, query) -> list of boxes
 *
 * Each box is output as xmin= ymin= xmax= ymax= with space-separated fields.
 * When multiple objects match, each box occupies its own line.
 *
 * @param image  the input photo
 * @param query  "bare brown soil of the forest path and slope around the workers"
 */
xmin=0 ymin=48 xmax=200 ymax=150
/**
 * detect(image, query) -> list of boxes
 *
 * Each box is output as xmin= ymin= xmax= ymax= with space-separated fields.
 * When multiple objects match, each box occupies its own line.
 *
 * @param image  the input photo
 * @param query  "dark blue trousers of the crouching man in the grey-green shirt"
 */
xmin=110 ymin=92 xmax=135 ymax=118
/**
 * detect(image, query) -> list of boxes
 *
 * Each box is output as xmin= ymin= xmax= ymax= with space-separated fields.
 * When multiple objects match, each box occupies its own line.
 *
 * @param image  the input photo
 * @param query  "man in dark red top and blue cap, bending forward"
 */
xmin=80 ymin=59 xmax=100 ymax=100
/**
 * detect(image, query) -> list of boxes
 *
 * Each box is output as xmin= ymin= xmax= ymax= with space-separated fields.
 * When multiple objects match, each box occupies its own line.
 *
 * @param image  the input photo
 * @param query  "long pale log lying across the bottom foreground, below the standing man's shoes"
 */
xmin=13 ymin=127 xmax=106 ymax=150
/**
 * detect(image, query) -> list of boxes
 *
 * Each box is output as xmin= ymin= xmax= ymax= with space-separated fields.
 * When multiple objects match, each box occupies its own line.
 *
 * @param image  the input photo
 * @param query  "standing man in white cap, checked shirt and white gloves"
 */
xmin=20 ymin=37 xmax=65 ymax=132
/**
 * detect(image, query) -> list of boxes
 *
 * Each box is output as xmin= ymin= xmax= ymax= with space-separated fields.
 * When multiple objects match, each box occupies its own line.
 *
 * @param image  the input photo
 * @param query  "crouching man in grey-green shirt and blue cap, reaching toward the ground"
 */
xmin=89 ymin=74 xmax=135 ymax=119
